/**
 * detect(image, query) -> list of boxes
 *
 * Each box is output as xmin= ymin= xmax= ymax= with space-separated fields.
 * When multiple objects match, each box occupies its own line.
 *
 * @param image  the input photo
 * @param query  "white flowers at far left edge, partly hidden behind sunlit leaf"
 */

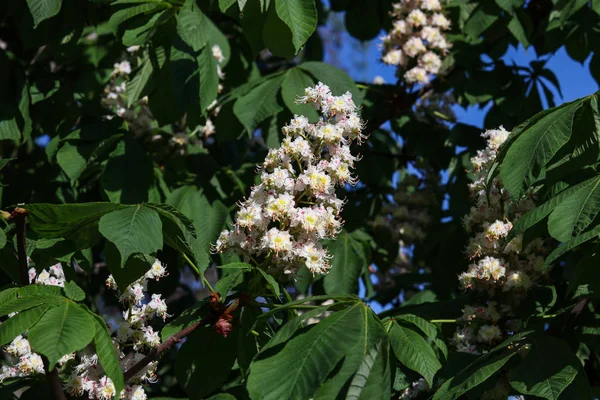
xmin=0 ymin=263 xmax=71 ymax=383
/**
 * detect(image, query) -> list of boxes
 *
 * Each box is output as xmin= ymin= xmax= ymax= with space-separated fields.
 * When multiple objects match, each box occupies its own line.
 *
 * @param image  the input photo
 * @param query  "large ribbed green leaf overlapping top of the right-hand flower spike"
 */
xmin=500 ymin=95 xmax=583 ymax=199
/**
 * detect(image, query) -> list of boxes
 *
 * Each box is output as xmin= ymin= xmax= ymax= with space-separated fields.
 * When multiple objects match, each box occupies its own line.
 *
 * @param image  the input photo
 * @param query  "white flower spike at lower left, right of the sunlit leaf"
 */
xmin=65 ymin=260 xmax=169 ymax=400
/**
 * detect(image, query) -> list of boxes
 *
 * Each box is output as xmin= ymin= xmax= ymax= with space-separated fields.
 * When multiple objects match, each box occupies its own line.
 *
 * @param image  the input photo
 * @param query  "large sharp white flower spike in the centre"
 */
xmin=215 ymin=82 xmax=365 ymax=274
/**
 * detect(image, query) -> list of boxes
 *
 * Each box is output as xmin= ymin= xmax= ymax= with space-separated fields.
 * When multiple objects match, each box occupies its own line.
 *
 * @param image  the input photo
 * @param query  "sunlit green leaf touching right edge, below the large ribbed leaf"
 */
xmin=548 ymin=175 xmax=600 ymax=242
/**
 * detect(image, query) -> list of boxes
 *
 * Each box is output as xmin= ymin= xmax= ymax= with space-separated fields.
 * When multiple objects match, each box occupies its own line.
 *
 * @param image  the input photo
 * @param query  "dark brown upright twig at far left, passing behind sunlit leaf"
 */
xmin=11 ymin=207 xmax=67 ymax=400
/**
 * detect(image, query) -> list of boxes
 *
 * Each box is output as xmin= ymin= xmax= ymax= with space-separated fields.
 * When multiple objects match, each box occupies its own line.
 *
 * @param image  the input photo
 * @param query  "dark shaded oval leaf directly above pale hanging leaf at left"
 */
xmin=100 ymin=137 xmax=154 ymax=204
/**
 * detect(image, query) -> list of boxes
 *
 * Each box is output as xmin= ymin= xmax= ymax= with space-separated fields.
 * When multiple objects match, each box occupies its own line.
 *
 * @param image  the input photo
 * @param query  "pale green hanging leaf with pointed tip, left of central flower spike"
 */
xmin=98 ymin=205 xmax=163 ymax=266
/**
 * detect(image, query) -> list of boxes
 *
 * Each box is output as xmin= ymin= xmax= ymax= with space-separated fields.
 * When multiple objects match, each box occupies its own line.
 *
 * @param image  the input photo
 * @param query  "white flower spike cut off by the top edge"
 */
xmin=381 ymin=0 xmax=450 ymax=83
